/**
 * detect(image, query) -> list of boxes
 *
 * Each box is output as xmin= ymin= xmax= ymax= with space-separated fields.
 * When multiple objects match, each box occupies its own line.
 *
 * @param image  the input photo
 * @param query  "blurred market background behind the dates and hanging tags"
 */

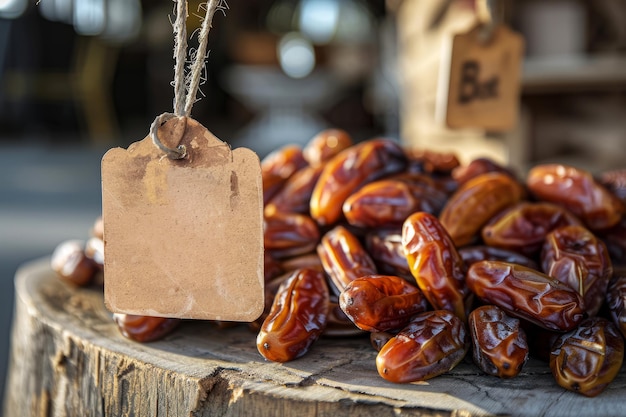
xmin=0 ymin=0 xmax=626 ymax=404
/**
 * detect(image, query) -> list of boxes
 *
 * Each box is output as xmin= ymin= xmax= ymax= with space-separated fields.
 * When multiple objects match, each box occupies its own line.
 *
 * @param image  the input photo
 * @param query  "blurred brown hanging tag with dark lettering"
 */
xmin=436 ymin=25 xmax=524 ymax=132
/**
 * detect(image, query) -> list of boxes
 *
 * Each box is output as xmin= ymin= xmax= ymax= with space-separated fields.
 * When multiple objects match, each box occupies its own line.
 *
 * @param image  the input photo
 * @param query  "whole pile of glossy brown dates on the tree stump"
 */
xmin=52 ymin=129 xmax=626 ymax=397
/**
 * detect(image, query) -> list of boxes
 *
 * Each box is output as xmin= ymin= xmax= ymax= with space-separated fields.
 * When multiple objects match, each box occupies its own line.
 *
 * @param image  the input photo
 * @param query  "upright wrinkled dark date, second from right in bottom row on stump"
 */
xmin=468 ymin=305 xmax=528 ymax=378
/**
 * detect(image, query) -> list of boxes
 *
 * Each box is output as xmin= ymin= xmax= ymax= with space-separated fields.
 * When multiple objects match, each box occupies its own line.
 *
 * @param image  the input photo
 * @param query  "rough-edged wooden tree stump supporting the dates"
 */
xmin=4 ymin=258 xmax=626 ymax=417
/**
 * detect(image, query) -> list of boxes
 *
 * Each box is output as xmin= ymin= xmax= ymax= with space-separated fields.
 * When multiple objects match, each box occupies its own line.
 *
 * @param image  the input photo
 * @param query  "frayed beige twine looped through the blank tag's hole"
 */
xmin=150 ymin=0 xmax=226 ymax=159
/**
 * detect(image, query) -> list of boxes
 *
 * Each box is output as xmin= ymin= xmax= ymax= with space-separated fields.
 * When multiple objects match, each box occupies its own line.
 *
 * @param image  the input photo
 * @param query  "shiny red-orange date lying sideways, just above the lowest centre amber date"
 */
xmin=339 ymin=275 xmax=428 ymax=332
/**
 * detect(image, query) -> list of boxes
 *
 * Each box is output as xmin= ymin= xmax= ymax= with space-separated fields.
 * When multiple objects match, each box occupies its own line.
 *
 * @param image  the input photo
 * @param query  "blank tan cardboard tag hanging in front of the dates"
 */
xmin=102 ymin=117 xmax=264 ymax=321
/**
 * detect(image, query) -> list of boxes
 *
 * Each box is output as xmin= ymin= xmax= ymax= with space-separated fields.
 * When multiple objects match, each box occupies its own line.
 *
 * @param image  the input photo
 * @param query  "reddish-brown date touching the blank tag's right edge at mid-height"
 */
xmin=263 ymin=211 xmax=320 ymax=259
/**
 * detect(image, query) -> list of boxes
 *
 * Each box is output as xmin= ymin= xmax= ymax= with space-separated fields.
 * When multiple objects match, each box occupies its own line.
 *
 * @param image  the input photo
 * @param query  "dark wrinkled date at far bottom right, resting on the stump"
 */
xmin=550 ymin=317 xmax=624 ymax=397
